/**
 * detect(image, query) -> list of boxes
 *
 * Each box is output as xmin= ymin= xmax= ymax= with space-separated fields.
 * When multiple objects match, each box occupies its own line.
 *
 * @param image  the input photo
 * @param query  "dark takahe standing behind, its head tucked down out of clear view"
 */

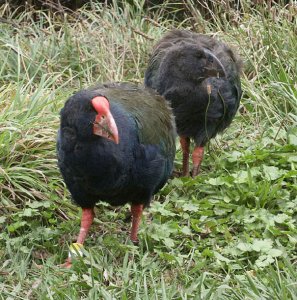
xmin=145 ymin=29 xmax=242 ymax=176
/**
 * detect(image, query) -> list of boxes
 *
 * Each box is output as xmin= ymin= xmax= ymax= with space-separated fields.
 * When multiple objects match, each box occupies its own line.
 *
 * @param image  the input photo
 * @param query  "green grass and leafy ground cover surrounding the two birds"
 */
xmin=0 ymin=0 xmax=297 ymax=299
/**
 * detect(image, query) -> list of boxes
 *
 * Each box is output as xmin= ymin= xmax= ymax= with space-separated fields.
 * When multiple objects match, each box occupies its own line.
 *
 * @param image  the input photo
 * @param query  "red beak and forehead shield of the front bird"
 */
xmin=91 ymin=96 xmax=119 ymax=144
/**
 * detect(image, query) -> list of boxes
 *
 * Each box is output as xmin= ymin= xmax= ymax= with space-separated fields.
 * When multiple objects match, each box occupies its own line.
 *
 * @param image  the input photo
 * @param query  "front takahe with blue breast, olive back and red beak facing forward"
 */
xmin=57 ymin=83 xmax=175 ymax=267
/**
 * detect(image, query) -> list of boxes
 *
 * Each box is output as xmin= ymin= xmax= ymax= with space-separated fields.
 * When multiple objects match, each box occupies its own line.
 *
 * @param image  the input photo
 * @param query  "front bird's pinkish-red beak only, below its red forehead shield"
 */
xmin=93 ymin=112 xmax=119 ymax=144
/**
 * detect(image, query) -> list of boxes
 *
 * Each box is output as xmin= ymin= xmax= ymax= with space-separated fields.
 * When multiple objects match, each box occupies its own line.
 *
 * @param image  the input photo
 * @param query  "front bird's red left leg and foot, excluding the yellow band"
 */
xmin=61 ymin=208 xmax=95 ymax=268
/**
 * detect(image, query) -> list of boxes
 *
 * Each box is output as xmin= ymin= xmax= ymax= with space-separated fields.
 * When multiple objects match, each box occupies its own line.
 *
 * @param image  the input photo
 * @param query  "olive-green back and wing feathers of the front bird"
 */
xmin=89 ymin=83 xmax=175 ymax=155
